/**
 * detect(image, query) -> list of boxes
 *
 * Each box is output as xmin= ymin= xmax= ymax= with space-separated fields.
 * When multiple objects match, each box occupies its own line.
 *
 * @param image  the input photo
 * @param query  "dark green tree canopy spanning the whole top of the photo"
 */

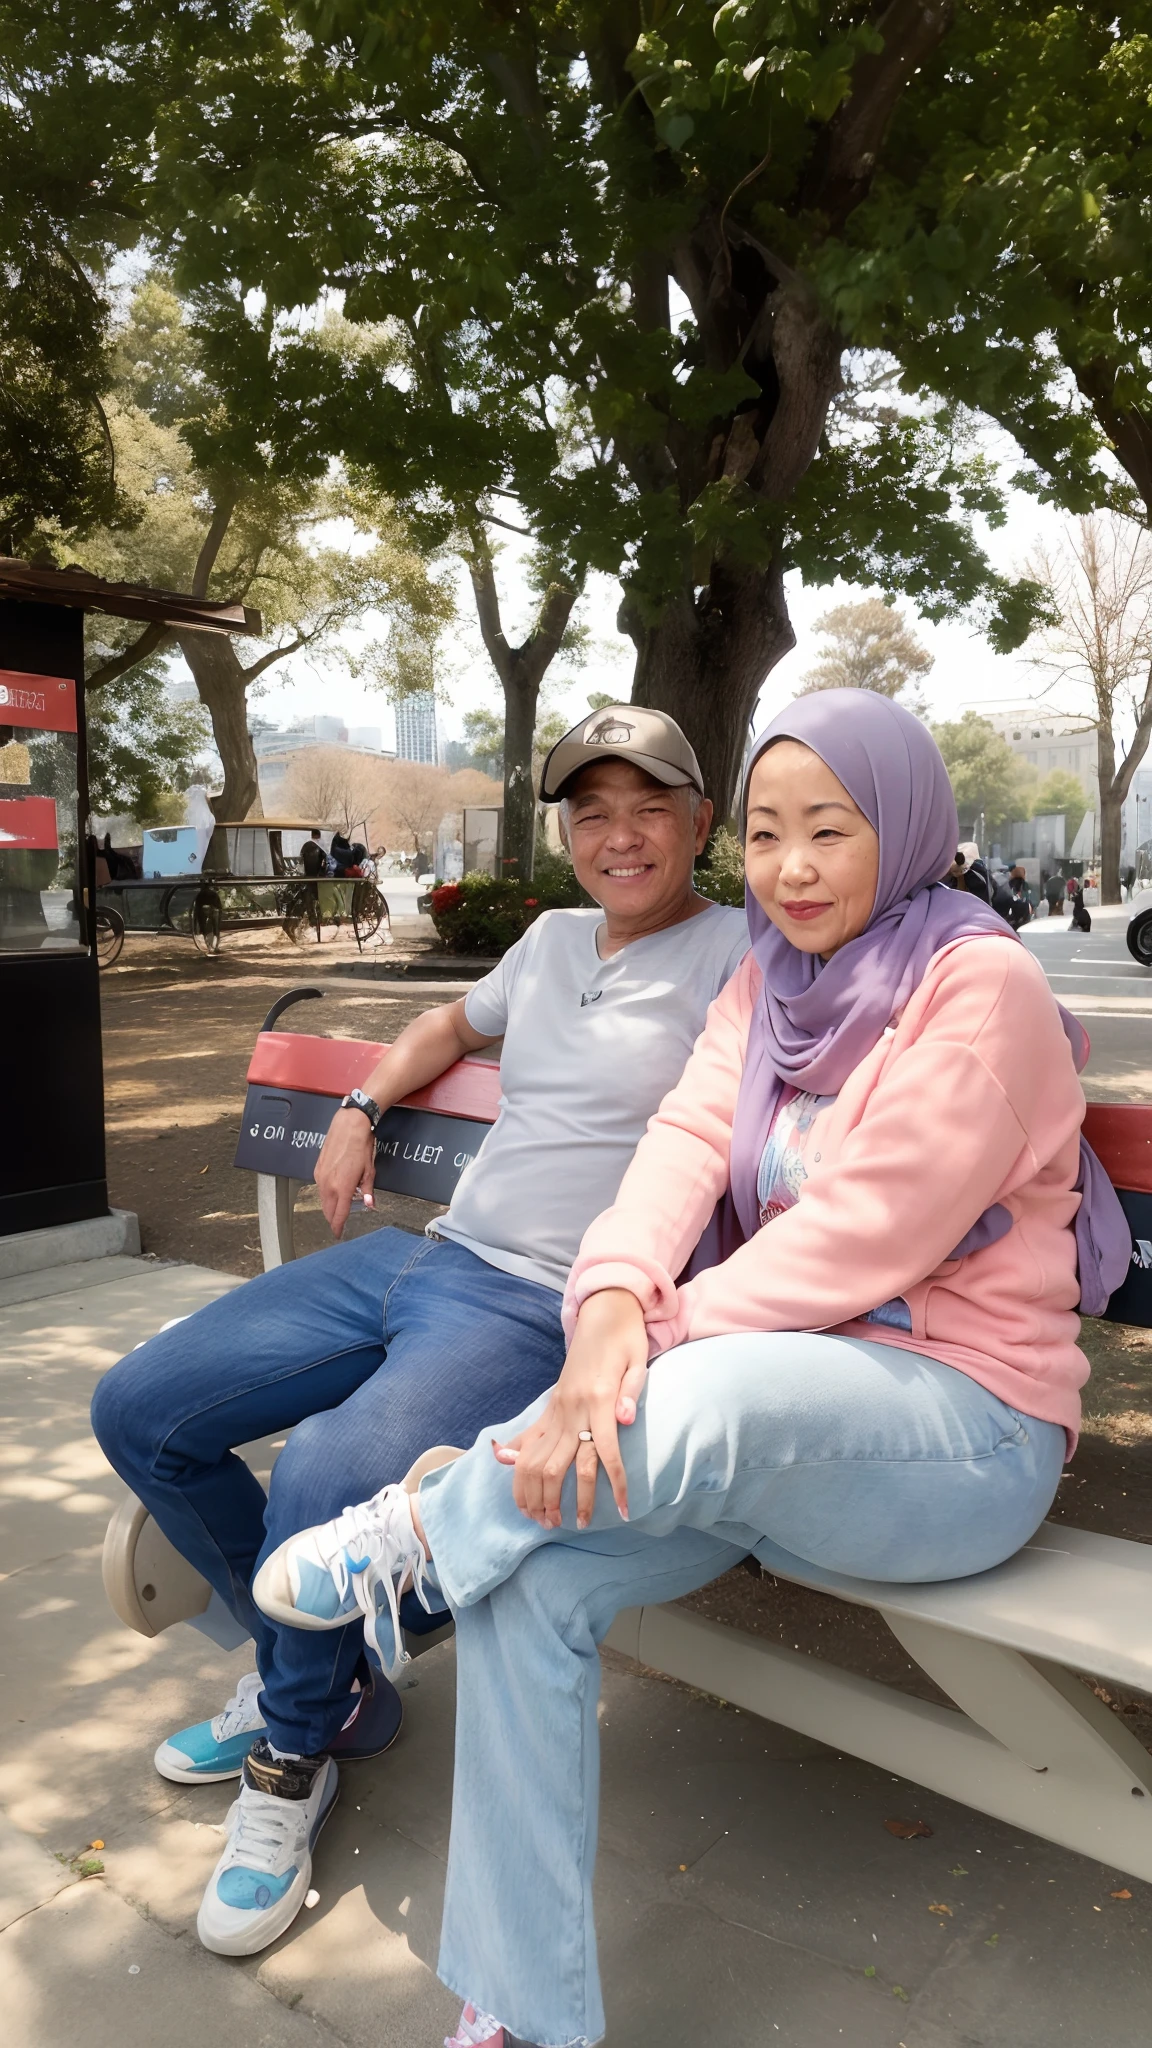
xmin=8 ymin=0 xmax=1152 ymax=847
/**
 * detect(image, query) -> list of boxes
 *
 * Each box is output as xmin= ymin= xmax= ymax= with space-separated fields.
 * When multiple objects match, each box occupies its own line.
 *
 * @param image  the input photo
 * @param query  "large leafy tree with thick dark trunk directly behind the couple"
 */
xmin=139 ymin=0 xmax=1045 ymax=851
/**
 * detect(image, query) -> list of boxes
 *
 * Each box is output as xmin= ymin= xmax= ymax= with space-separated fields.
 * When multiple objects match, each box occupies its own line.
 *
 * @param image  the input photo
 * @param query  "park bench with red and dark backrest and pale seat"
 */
xmin=100 ymin=989 xmax=1152 ymax=1882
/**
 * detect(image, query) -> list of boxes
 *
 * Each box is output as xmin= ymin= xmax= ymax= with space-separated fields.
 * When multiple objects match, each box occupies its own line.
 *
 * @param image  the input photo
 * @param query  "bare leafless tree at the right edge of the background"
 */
xmin=1029 ymin=512 xmax=1152 ymax=903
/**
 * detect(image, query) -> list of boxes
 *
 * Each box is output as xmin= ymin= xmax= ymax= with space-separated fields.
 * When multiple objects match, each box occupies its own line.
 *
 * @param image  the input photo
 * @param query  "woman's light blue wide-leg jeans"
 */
xmin=420 ymin=1333 xmax=1066 ymax=2048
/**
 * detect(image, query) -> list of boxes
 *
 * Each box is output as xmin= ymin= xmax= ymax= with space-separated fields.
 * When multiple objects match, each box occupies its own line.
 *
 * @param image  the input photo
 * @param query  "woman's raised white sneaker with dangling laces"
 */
xmin=252 ymin=1485 xmax=430 ymax=1677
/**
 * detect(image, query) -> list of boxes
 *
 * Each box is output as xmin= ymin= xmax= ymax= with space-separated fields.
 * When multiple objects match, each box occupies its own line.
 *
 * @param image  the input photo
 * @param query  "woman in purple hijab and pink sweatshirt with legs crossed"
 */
xmin=254 ymin=690 xmax=1127 ymax=2048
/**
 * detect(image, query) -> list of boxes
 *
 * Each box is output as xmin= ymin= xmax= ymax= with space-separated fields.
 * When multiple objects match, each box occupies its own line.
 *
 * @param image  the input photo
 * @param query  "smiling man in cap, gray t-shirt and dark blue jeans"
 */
xmin=92 ymin=705 xmax=748 ymax=1954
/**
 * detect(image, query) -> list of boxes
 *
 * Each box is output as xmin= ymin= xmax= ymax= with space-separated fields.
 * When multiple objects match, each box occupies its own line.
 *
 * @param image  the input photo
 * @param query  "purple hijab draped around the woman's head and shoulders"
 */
xmin=721 ymin=690 xmax=1132 ymax=1315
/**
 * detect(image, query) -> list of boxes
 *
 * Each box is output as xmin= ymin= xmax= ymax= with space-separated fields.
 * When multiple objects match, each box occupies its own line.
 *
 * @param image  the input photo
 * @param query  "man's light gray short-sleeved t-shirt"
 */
xmin=430 ymin=903 xmax=748 ymax=1290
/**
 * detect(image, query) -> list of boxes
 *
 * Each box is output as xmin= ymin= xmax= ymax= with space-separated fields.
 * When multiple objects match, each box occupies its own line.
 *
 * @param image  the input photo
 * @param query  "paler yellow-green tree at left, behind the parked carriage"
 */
xmin=71 ymin=276 xmax=451 ymax=819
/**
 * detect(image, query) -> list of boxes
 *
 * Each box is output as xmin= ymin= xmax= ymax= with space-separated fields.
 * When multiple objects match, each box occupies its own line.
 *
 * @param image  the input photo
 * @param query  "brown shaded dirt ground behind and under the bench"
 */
xmin=100 ymin=934 xmax=1152 ymax=1749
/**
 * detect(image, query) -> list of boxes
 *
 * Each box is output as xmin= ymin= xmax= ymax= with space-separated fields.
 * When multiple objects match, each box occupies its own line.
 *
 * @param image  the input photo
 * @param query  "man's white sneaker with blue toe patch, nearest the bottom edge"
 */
xmin=197 ymin=1737 xmax=338 ymax=1956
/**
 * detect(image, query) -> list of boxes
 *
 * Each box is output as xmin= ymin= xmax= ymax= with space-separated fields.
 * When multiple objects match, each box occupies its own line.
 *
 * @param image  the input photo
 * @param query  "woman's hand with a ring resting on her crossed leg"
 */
xmin=494 ymin=1288 xmax=648 ymax=1530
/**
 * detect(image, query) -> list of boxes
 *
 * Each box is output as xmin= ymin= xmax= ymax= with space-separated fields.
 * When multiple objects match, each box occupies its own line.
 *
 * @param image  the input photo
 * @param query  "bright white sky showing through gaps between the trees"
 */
xmin=239 ymin=464 xmax=1084 ymax=748
